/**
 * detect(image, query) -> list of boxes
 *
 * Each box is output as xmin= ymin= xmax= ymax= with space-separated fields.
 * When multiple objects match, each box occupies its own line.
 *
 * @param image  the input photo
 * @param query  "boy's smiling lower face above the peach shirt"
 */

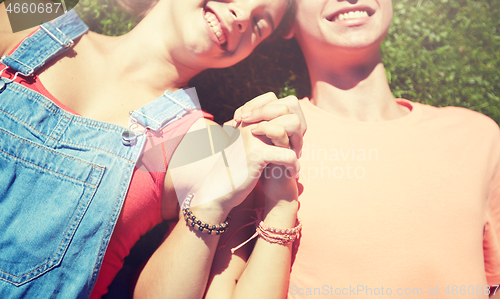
xmin=294 ymin=0 xmax=392 ymax=59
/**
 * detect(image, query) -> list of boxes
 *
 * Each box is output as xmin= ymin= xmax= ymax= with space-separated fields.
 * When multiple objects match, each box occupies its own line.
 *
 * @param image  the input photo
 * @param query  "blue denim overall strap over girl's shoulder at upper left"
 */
xmin=0 ymin=9 xmax=89 ymax=76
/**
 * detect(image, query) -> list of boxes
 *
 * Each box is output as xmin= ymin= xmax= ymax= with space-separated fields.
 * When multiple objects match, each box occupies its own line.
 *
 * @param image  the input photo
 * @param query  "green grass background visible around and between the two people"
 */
xmin=0 ymin=0 xmax=500 ymax=123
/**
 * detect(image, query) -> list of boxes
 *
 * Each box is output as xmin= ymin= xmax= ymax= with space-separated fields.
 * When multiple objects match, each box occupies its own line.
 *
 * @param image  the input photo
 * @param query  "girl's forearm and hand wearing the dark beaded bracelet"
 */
xmin=134 ymin=94 xmax=304 ymax=298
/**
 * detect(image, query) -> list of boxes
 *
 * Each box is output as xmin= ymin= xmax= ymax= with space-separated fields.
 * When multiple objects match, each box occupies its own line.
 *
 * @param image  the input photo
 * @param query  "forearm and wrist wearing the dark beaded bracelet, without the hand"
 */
xmin=134 ymin=204 xmax=227 ymax=299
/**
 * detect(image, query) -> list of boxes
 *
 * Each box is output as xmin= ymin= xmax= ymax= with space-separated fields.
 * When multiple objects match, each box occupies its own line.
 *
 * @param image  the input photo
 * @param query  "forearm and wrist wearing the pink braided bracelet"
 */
xmin=233 ymin=201 xmax=298 ymax=299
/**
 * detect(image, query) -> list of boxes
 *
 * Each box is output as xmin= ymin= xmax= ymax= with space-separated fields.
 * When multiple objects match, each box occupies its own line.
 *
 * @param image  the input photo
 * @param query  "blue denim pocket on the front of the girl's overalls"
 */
xmin=0 ymin=128 xmax=104 ymax=285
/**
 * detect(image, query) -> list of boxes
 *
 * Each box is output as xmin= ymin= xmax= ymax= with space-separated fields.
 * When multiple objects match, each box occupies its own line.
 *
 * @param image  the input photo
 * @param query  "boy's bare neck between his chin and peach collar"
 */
xmin=307 ymin=53 xmax=409 ymax=122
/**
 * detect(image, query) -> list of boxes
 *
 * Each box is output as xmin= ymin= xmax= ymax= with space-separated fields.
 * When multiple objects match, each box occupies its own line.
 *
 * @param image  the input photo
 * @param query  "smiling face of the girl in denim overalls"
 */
xmin=165 ymin=0 xmax=289 ymax=69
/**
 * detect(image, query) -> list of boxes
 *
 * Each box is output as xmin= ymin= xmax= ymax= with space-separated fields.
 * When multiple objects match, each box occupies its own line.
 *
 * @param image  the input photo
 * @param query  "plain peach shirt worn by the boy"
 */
xmin=289 ymin=99 xmax=500 ymax=298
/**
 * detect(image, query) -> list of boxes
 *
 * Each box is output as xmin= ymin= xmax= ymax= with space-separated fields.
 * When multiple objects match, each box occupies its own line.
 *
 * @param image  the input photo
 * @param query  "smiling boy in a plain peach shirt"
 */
xmin=215 ymin=0 xmax=500 ymax=298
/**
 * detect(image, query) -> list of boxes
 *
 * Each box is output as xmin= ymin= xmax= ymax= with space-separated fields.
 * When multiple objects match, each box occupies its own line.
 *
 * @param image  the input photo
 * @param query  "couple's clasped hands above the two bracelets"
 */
xmin=188 ymin=93 xmax=306 ymax=211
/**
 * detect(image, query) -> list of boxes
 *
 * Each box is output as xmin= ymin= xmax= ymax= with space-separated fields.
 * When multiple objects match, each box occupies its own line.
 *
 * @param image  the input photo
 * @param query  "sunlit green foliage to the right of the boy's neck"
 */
xmin=382 ymin=0 xmax=500 ymax=123
